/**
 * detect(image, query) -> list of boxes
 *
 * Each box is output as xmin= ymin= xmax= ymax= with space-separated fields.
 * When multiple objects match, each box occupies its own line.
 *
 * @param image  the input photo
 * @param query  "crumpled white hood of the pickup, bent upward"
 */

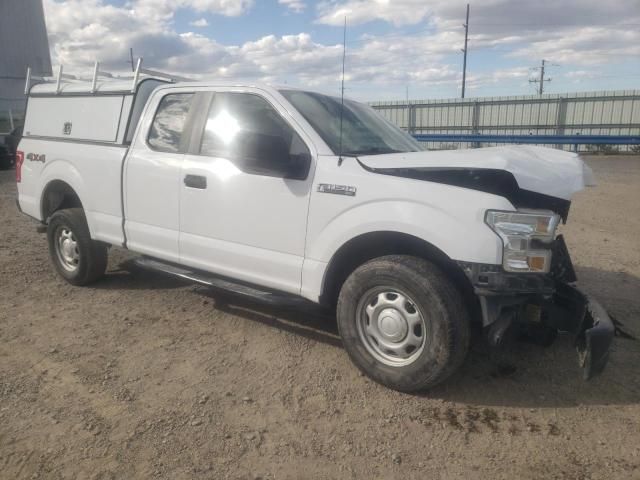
xmin=358 ymin=145 xmax=595 ymax=200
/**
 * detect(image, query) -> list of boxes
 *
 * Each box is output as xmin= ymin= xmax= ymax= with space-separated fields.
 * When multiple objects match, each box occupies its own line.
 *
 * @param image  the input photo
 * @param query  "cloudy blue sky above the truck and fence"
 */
xmin=43 ymin=0 xmax=640 ymax=101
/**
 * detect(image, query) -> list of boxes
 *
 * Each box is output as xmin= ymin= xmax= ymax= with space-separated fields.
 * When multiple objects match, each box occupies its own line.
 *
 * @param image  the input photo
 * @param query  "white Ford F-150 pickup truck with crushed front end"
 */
xmin=16 ymin=67 xmax=614 ymax=391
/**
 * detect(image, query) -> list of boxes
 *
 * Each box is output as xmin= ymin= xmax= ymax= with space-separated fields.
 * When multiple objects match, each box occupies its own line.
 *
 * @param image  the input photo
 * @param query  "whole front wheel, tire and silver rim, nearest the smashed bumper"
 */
xmin=337 ymin=255 xmax=470 ymax=392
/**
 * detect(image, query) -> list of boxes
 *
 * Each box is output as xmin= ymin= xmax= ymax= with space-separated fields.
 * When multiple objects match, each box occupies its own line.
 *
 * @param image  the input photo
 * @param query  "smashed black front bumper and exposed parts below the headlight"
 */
xmin=459 ymin=235 xmax=615 ymax=380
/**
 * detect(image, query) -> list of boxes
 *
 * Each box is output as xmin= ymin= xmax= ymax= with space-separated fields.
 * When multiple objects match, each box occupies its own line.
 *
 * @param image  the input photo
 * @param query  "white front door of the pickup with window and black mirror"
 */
xmin=179 ymin=90 xmax=313 ymax=294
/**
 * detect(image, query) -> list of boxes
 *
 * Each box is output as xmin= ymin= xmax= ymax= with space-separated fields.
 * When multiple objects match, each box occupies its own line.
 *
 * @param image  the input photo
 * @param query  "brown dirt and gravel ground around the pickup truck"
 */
xmin=0 ymin=156 xmax=640 ymax=479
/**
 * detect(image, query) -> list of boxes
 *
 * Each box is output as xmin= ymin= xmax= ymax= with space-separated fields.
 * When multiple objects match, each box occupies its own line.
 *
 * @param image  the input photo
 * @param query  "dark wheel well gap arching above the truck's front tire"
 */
xmin=320 ymin=232 xmax=477 ymax=313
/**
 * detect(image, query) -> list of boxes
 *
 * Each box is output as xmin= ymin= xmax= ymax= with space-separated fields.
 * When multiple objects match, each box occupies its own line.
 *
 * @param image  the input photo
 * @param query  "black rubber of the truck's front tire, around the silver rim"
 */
xmin=337 ymin=255 xmax=470 ymax=392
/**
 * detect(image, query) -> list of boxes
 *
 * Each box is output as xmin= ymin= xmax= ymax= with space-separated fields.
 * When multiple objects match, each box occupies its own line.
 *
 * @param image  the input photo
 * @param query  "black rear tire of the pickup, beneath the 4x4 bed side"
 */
xmin=47 ymin=208 xmax=108 ymax=286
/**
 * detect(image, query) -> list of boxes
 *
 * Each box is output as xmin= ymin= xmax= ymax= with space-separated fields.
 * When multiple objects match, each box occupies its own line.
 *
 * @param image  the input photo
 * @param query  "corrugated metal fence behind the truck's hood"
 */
xmin=371 ymin=90 xmax=640 ymax=151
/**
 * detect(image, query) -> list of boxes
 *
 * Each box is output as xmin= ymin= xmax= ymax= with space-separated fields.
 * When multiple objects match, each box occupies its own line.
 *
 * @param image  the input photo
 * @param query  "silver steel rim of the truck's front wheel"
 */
xmin=356 ymin=287 xmax=428 ymax=367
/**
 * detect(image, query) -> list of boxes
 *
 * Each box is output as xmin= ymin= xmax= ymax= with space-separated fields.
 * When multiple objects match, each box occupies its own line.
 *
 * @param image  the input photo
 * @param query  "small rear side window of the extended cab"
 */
xmin=148 ymin=93 xmax=193 ymax=153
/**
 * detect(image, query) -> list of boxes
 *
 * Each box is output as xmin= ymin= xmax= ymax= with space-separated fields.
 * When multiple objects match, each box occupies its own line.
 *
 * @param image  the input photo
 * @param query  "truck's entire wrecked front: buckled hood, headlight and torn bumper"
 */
xmin=358 ymin=145 xmax=615 ymax=379
